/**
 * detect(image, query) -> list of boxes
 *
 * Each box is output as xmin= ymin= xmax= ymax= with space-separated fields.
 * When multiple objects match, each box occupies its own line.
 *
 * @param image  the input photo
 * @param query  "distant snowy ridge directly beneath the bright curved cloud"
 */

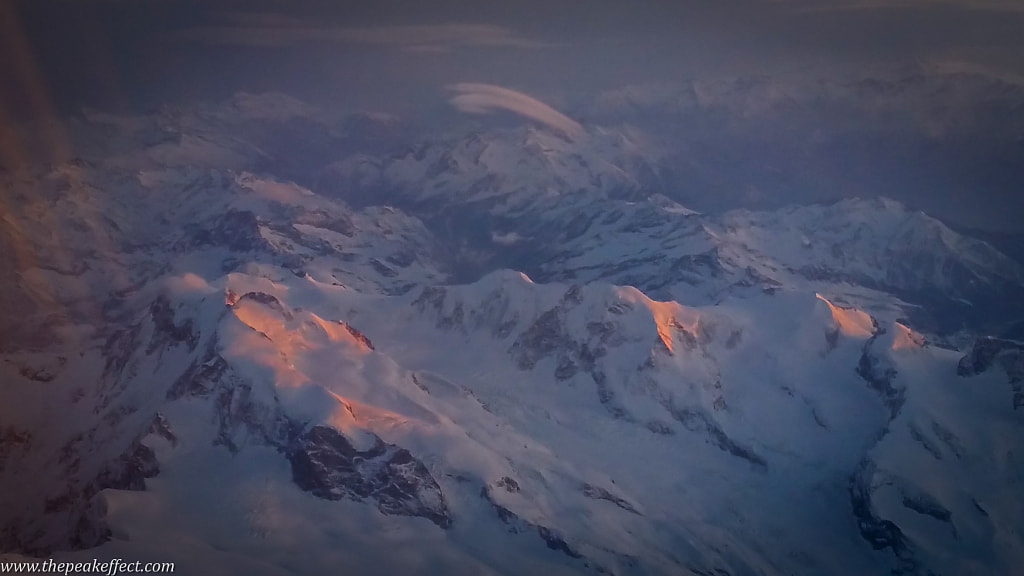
xmin=321 ymin=128 xmax=667 ymax=215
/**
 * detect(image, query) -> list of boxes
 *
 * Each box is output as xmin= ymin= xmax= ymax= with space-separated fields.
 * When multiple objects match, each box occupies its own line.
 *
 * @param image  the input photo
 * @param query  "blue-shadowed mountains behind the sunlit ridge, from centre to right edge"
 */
xmin=322 ymin=128 xmax=1024 ymax=331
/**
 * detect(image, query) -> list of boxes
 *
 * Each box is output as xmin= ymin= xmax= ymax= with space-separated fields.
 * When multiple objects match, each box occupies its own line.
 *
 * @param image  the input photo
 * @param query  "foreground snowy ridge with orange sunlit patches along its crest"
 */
xmin=4 ymin=266 xmax=1024 ymax=574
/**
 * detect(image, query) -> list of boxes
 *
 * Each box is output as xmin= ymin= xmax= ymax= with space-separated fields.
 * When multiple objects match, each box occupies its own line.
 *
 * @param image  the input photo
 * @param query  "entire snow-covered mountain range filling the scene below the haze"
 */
xmin=0 ymin=96 xmax=1024 ymax=576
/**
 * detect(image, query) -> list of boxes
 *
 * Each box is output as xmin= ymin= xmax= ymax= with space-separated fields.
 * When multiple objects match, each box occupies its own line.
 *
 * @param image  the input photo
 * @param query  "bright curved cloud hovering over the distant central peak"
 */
xmin=449 ymin=82 xmax=584 ymax=138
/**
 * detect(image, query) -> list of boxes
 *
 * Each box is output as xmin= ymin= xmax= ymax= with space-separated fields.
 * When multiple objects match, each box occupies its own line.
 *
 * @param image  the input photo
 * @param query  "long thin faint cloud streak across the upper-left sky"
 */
xmin=174 ymin=13 xmax=552 ymax=52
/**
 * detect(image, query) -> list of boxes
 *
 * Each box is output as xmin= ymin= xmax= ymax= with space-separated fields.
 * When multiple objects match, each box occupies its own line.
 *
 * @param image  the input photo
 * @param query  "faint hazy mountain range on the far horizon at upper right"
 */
xmin=580 ymin=61 xmax=1024 ymax=139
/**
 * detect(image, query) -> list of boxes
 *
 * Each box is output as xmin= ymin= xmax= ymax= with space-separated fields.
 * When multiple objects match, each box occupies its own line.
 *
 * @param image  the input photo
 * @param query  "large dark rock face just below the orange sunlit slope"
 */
xmin=288 ymin=426 xmax=452 ymax=529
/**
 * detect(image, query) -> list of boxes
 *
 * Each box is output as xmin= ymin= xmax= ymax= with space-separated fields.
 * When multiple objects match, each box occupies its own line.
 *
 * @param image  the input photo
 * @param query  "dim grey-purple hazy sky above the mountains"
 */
xmin=0 ymin=0 xmax=1024 ymax=232
